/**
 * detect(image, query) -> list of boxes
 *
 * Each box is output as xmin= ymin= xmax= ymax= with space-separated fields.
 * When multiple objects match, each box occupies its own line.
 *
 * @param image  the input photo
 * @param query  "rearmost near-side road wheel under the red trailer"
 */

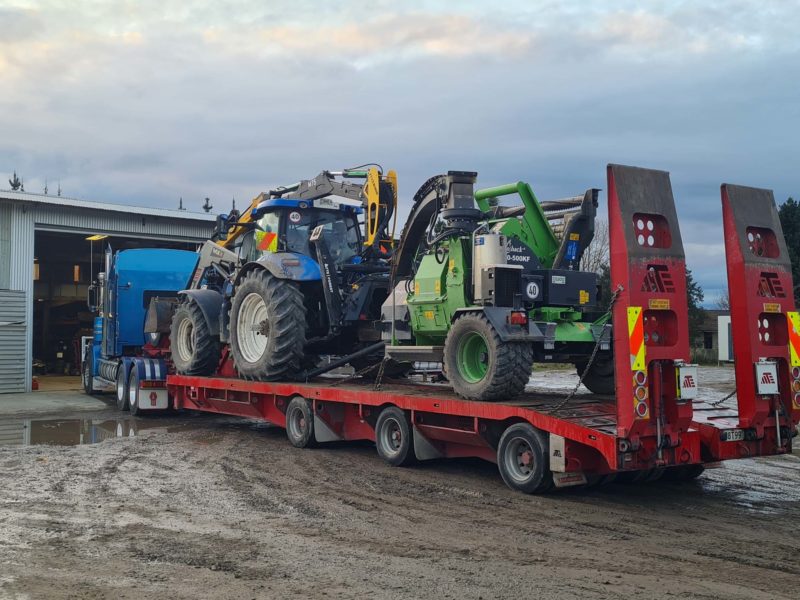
xmin=497 ymin=423 xmax=553 ymax=494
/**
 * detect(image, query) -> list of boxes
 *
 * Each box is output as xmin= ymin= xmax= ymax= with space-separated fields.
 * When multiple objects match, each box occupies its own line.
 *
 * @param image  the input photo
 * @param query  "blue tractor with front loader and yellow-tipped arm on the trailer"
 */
xmin=171 ymin=167 xmax=397 ymax=381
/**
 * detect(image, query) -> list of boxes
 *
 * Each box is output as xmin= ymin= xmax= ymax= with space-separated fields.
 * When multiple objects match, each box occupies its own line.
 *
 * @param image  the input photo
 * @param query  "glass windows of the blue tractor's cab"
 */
xmin=286 ymin=210 xmax=361 ymax=264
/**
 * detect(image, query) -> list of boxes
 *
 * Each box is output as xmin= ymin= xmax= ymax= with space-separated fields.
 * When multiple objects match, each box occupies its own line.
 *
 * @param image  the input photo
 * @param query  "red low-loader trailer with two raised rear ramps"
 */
xmin=167 ymin=165 xmax=800 ymax=493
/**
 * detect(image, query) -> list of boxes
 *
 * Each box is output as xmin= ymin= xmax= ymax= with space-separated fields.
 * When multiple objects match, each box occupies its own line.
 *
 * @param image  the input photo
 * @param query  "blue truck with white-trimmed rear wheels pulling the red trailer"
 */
xmin=82 ymin=248 xmax=197 ymax=414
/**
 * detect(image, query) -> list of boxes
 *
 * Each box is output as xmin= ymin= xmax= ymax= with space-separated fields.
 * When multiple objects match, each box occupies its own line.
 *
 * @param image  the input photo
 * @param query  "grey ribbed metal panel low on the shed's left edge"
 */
xmin=0 ymin=290 xmax=29 ymax=392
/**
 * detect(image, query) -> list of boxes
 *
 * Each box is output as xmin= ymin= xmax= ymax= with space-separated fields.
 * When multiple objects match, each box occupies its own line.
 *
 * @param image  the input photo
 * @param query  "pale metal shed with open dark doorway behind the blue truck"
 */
xmin=0 ymin=191 xmax=215 ymax=393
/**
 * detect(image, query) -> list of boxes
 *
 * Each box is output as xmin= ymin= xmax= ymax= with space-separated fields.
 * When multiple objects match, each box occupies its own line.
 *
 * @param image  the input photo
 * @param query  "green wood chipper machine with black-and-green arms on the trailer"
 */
xmin=382 ymin=171 xmax=614 ymax=400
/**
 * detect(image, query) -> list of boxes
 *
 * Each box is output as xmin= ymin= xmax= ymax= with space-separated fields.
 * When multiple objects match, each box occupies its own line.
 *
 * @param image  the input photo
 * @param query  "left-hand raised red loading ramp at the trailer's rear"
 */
xmin=608 ymin=165 xmax=699 ymax=442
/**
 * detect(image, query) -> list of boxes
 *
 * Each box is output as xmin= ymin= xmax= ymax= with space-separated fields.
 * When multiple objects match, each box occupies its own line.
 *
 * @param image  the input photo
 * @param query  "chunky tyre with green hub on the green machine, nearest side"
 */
xmin=443 ymin=314 xmax=533 ymax=400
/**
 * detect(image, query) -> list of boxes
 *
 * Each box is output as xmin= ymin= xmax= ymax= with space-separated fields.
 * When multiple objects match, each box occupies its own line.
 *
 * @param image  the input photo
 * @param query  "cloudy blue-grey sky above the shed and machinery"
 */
xmin=0 ymin=0 xmax=800 ymax=304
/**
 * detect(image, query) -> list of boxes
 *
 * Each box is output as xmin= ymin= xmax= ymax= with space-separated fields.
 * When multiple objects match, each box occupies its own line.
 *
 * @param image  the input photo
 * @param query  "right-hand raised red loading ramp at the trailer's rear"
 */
xmin=721 ymin=184 xmax=800 ymax=440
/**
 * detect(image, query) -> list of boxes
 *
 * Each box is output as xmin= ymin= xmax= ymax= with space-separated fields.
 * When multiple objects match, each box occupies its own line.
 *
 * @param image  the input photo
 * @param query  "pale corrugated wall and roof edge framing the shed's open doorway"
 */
xmin=0 ymin=191 xmax=215 ymax=393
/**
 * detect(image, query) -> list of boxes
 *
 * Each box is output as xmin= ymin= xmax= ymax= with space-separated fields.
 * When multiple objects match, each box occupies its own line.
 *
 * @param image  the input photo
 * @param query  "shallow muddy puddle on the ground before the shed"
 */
xmin=0 ymin=418 xmax=164 ymax=446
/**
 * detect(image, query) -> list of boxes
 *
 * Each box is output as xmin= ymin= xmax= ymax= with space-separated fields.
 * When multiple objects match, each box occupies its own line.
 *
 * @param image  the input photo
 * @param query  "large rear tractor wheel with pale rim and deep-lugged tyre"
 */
xmin=230 ymin=270 xmax=306 ymax=381
